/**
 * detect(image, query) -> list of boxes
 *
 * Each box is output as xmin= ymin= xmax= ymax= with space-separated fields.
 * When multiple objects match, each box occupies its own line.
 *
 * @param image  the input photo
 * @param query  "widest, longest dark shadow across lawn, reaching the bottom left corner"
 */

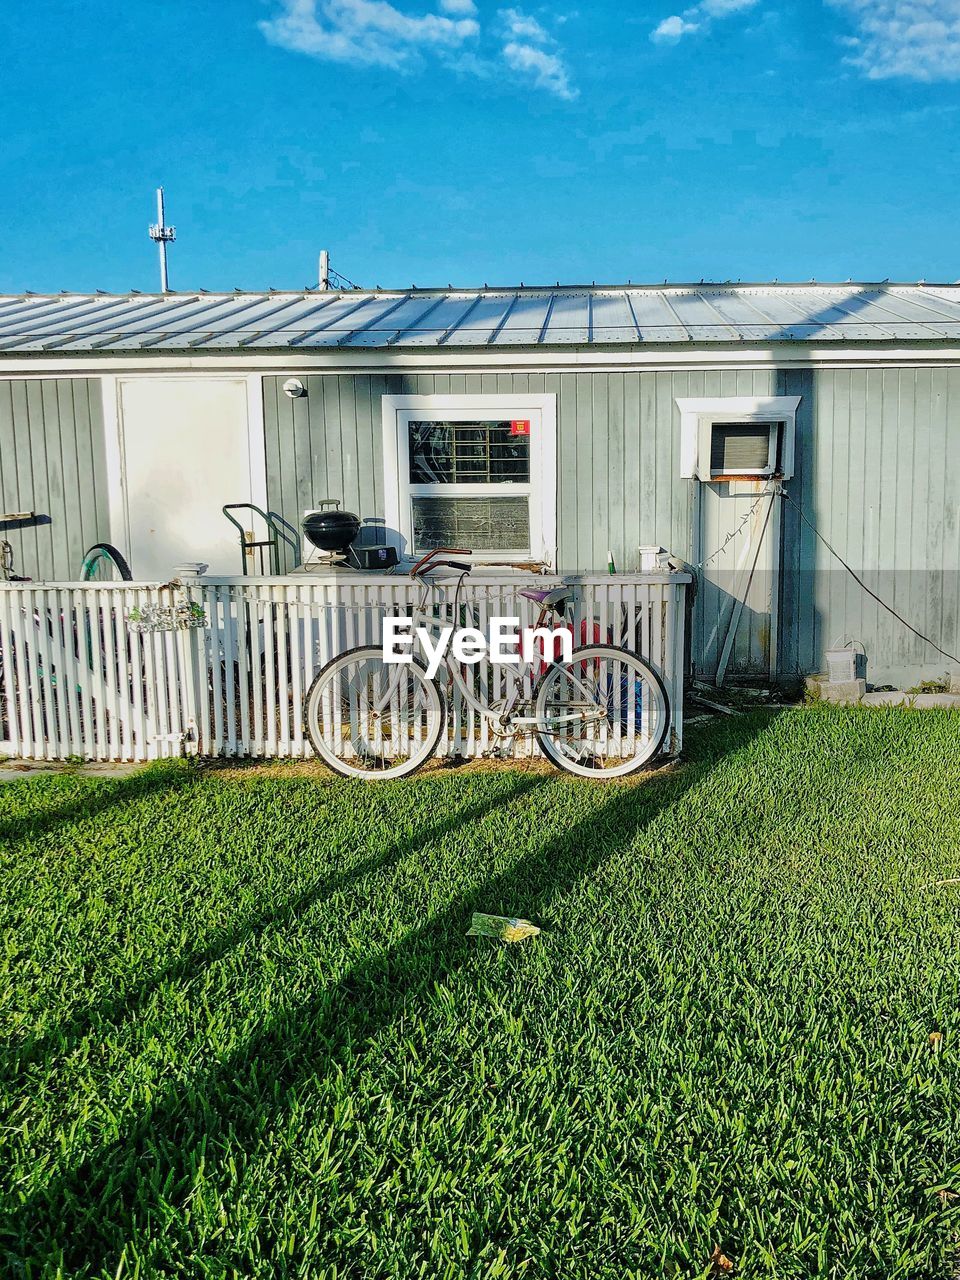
xmin=0 ymin=717 xmax=769 ymax=1277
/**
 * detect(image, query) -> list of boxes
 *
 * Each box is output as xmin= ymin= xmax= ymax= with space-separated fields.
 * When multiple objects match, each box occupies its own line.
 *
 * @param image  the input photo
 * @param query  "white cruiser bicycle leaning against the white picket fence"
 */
xmin=303 ymin=547 xmax=669 ymax=781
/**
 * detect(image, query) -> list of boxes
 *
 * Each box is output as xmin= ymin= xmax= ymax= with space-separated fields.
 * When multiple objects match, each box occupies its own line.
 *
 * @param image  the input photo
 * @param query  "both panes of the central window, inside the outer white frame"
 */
xmin=407 ymin=419 xmax=531 ymax=557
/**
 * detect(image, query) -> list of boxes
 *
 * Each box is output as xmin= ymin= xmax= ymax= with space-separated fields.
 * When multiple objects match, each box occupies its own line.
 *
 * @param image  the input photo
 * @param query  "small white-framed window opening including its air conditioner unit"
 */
xmin=677 ymin=396 xmax=800 ymax=480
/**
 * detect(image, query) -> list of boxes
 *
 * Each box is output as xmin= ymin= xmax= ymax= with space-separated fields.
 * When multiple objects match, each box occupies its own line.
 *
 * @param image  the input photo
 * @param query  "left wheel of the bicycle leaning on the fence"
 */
xmin=303 ymin=646 xmax=444 ymax=781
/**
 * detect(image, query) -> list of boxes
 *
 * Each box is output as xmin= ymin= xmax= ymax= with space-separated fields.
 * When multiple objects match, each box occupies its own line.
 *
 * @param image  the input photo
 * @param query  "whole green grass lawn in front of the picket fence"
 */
xmin=0 ymin=708 xmax=960 ymax=1280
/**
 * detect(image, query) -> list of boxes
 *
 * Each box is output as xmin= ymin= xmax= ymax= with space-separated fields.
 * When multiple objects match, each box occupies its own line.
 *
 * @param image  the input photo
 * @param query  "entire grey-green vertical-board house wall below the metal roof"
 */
xmin=0 ymin=352 xmax=960 ymax=686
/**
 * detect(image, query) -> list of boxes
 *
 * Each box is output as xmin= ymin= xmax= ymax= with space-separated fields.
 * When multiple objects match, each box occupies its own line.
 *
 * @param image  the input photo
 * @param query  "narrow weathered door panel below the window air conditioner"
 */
xmin=694 ymin=480 xmax=781 ymax=685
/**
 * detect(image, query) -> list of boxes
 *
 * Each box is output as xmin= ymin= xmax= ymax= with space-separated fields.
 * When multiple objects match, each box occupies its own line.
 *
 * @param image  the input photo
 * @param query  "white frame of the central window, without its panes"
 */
xmin=381 ymin=394 xmax=557 ymax=567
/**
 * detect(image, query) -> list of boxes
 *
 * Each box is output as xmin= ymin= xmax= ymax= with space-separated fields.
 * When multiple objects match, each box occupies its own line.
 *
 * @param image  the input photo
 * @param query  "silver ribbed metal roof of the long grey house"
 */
xmin=0 ymin=282 xmax=960 ymax=355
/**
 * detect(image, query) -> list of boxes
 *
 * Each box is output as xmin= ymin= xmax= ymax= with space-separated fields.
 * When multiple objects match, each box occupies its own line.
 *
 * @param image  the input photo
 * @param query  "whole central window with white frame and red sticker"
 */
xmin=383 ymin=396 xmax=557 ymax=564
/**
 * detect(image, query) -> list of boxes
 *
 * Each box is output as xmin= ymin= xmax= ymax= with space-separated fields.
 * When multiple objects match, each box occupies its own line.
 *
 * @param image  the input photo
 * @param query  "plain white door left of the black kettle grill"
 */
xmin=118 ymin=378 xmax=252 ymax=581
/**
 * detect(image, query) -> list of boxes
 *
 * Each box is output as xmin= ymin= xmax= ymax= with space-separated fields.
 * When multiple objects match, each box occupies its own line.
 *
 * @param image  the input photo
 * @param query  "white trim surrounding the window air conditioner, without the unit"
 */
xmin=677 ymin=396 xmax=801 ymax=481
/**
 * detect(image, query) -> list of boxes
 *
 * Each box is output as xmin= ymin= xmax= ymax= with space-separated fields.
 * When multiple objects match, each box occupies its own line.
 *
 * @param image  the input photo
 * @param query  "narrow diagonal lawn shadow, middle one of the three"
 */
xmin=0 ymin=777 xmax=548 ymax=1082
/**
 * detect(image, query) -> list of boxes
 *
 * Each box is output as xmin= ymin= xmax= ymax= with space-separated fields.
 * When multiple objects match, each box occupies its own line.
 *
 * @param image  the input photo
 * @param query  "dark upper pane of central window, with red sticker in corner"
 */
xmin=410 ymin=422 xmax=530 ymax=483
